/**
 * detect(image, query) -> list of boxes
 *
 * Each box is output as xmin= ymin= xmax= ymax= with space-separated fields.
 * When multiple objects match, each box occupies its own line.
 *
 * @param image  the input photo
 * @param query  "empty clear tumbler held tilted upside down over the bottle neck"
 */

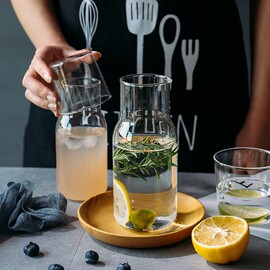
xmin=50 ymin=51 xmax=111 ymax=115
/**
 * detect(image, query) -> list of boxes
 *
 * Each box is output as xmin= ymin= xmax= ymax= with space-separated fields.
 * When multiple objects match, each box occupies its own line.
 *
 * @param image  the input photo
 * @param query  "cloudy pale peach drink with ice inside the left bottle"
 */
xmin=56 ymin=127 xmax=107 ymax=201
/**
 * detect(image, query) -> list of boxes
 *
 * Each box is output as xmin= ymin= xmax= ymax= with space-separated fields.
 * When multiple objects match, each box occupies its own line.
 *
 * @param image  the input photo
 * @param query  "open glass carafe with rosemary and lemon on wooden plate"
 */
xmin=113 ymin=74 xmax=178 ymax=230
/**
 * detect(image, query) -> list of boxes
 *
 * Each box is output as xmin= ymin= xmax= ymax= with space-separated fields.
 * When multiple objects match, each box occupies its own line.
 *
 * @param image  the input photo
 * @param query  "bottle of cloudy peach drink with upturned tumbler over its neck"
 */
xmin=51 ymin=52 xmax=110 ymax=201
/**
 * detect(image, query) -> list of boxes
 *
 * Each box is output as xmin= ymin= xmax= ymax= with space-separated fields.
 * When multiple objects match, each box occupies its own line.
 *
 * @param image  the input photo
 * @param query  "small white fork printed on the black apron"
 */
xmin=181 ymin=39 xmax=200 ymax=90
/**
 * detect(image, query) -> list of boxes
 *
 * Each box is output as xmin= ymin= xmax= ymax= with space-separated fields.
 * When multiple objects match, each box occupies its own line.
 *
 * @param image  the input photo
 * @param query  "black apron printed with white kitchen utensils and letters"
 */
xmin=24 ymin=0 xmax=249 ymax=172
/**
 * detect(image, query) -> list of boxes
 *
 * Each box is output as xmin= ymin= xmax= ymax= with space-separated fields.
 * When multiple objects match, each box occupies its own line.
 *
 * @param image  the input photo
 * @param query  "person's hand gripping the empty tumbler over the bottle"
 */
xmin=22 ymin=46 xmax=100 ymax=116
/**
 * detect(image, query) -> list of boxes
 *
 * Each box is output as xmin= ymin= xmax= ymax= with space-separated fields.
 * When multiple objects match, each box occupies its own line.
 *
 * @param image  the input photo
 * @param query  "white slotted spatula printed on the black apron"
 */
xmin=126 ymin=0 xmax=158 ymax=74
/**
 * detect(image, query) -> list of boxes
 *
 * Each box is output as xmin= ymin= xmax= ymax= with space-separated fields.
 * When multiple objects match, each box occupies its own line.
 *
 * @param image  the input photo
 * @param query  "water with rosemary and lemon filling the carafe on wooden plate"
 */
xmin=113 ymin=137 xmax=177 ymax=230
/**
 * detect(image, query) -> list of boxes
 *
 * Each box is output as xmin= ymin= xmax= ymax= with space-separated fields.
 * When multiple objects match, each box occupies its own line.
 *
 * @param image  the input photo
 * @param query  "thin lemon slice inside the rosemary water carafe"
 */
xmin=113 ymin=178 xmax=131 ymax=226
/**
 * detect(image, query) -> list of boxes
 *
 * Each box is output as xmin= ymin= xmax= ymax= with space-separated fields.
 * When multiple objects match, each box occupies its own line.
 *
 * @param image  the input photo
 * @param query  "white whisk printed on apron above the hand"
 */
xmin=79 ymin=0 xmax=98 ymax=49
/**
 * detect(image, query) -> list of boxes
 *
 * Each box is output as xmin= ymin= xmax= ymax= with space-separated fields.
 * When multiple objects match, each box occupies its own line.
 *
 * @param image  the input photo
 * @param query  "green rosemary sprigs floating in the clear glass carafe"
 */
xmin=113 ymin=137 xmax=177 ymax=181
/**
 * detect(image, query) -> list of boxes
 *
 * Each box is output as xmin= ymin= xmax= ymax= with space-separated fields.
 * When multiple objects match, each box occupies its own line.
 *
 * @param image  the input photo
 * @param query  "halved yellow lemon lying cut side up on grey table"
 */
xmin=191 ymin=216 xmax=250 ymax=264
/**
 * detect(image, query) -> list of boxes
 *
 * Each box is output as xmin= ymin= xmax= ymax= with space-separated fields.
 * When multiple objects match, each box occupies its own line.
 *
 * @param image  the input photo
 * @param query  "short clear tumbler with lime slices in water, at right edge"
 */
xmin=214 ymin=147 xmax=270 ymax=224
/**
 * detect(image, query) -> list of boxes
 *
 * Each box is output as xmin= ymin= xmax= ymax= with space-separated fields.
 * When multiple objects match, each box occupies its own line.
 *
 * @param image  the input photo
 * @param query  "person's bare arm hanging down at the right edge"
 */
xmin=236 ymin=0 xmax=270 ymax=149
